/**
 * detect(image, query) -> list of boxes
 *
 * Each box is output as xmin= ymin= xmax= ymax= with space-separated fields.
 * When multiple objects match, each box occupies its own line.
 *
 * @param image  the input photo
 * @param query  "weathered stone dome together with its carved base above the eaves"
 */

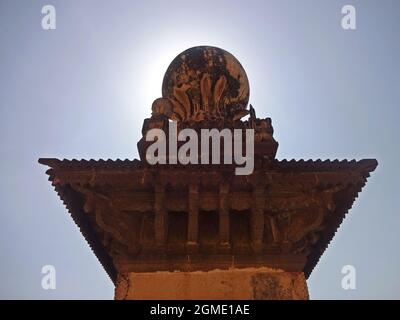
xmin=138 ymin=46 xmax=278 ymax=159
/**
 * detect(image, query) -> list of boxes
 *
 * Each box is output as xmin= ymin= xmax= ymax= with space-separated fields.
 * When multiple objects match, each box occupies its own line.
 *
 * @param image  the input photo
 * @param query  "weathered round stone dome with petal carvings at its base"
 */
xmin=162 ymin=46 xmax=250 ymax=121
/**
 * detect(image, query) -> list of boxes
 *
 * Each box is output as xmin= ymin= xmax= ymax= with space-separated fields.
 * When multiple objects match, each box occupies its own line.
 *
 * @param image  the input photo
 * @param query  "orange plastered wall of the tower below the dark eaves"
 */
xmin=115 ymin=267 xmax=309 ymax=300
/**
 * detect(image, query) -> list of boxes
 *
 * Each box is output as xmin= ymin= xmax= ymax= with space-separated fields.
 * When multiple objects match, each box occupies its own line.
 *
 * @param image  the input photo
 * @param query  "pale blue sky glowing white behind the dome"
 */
xmin=0 ymin=0 xmax=400 ymax=299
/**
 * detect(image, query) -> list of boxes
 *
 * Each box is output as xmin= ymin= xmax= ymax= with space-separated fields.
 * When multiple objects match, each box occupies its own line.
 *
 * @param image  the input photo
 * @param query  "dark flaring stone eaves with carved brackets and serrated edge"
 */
xmin=39 ymin=159 xmax=377 ymax=290
